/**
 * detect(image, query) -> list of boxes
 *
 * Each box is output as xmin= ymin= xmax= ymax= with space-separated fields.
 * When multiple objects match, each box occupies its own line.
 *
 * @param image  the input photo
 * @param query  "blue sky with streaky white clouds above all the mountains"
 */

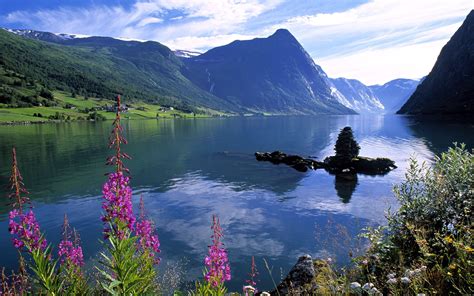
xmin=0 ymin=0 xmax=474 ymax=85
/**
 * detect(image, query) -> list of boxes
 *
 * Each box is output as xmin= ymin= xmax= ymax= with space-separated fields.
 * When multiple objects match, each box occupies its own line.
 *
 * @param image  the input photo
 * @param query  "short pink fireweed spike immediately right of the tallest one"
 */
xmin=135 ymin=197 xmax=161 ymax=264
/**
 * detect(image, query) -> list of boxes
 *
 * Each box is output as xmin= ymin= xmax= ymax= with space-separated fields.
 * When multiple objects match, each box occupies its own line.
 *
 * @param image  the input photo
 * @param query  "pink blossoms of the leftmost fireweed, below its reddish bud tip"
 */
xmin=8 ymin=210 xmax=47 ymax=252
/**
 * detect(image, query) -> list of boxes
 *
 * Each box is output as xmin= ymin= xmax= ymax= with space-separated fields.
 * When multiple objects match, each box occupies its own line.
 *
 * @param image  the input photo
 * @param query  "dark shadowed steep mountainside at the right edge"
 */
xmin=397 ymin=10 xmax=474 ymax=116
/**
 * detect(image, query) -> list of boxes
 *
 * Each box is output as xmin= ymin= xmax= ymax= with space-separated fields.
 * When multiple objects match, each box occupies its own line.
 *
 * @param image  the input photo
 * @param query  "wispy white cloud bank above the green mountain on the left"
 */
xmin=5 ymin=0 xmax=281 ymax=48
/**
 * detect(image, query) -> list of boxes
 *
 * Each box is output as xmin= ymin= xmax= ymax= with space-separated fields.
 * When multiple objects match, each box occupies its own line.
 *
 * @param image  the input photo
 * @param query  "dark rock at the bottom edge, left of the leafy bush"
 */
xmin=270 ymin=255 xmax=316 ymax=295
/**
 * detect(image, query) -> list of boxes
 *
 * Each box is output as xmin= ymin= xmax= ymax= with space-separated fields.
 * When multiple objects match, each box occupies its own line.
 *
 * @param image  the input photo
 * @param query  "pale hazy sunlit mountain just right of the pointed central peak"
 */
xmin=330 ymin=78 xmax=384 ymax=114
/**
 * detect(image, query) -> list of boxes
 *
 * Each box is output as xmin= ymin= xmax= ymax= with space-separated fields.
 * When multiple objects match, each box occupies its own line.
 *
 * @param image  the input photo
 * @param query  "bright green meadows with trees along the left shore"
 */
xmin=0 ymin=56 xmax=231 ymax=123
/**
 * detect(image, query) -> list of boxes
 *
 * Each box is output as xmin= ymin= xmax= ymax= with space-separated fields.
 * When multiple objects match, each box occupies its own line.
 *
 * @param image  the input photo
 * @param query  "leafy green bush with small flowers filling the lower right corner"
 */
xmin=312 ymin=145 xmax=474 ymax=295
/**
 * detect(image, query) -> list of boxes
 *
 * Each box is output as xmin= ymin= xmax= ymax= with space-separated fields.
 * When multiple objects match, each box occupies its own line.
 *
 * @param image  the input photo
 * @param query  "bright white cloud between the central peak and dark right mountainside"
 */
xmin=273 ymin=0 xmax=474 ymax=84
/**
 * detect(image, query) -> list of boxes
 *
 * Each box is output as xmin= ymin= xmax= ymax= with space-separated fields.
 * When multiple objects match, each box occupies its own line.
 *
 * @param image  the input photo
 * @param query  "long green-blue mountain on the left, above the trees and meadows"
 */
xmin=0 ymin=30 xmax=240 ymax=111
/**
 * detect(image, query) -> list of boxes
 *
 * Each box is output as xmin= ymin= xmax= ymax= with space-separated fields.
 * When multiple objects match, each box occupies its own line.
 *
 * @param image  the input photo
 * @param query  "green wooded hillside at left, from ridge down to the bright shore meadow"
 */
xmin=0 ymin=30 xmax=235 ymax=115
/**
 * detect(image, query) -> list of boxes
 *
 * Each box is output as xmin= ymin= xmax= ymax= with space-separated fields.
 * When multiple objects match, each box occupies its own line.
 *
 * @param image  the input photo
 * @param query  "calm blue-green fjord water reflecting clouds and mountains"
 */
xmin=0 ymin=116 xmax=474 ymax=290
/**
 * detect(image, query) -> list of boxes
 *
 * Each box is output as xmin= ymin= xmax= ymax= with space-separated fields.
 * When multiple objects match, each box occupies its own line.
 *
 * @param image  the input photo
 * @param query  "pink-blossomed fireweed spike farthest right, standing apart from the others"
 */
xmin=204 ymin=215 xmax=231 ymax=287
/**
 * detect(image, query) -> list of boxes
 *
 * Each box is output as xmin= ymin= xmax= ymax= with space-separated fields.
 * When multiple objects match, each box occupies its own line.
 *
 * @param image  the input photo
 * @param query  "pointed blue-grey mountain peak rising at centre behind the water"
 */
xmin=183 ymin=29 xmax=355 ymax=114
